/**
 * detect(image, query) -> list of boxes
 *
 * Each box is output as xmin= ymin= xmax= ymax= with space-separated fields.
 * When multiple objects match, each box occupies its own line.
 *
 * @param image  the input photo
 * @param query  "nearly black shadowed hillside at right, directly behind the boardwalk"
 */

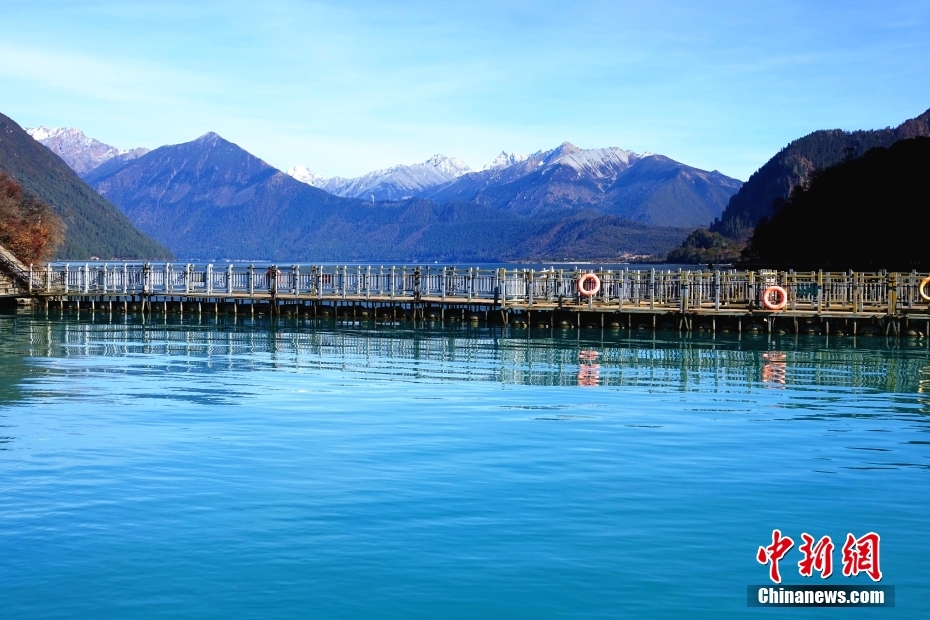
xmin=747 ymin=137 xmax=930 ymax=271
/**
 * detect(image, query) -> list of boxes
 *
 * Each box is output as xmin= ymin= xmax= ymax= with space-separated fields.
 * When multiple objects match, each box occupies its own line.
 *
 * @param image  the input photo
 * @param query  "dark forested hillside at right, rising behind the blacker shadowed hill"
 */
xmin=710 ymin=110 xmax=930 ymax=242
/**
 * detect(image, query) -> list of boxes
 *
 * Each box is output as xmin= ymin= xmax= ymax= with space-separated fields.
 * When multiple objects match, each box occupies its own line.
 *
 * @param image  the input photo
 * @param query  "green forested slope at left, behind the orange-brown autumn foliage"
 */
xmin=0 ymin=114 xmax=171 ymax=260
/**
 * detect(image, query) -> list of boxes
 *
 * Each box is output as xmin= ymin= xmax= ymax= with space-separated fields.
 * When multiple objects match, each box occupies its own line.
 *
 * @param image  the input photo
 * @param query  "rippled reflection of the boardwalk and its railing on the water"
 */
xmin=7 ymin=315 xmax=930 ymax=394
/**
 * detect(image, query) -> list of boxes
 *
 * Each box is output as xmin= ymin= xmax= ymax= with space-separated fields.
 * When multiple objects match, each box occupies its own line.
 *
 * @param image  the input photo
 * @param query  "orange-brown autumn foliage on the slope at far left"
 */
xmin=0 ymin=171 xmax=65 ymax=265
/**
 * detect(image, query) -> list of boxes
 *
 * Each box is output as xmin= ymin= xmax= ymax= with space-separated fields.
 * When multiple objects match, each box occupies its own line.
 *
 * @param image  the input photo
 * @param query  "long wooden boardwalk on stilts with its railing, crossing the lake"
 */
xmin=7 ymin=263 xmax=930 ymax=336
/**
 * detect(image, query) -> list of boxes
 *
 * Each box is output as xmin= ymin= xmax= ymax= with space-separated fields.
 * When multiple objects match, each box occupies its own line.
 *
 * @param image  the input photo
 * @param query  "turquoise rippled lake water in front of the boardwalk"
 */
xmin=0 ymin=313 xmax=930 ymax=619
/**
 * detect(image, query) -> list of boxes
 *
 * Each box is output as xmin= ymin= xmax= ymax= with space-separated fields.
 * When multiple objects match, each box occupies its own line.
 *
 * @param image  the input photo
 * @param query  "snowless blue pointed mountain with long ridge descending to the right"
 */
xmin=85 ymin=133 xmax=688 ymax=262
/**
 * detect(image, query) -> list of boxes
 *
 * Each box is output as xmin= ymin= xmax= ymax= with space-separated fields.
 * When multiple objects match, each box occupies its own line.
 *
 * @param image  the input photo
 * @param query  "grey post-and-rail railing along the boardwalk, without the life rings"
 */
xmin=18 ymin=263 xmax=928 ymax=319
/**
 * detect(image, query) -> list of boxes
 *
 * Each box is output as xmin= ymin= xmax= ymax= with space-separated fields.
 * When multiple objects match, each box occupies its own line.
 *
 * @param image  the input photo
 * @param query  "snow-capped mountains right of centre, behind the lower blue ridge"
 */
xmin=288 ymin=142 xmax=742 ymax=227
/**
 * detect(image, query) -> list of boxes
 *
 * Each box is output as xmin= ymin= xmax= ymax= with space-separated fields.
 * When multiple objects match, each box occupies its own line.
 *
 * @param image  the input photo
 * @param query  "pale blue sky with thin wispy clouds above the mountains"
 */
xmin=0 ymin=0 xmax=930 ymax=180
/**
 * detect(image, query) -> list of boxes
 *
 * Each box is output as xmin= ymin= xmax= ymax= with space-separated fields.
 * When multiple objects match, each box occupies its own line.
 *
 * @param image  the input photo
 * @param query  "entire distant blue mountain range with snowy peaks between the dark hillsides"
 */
xmin=21 ymin=127 xmax=740 ymax=261
